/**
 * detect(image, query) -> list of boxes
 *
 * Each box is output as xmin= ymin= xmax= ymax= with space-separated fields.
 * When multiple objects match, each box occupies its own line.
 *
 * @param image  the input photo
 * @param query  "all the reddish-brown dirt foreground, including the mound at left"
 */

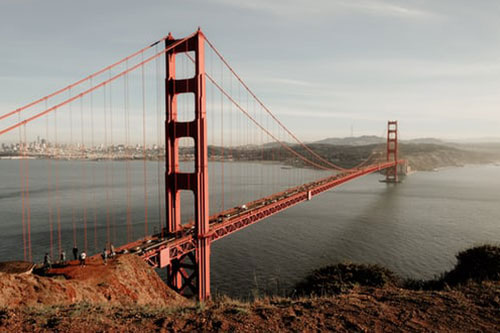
xmin=0 ymin=255 xmax=500 ymax=332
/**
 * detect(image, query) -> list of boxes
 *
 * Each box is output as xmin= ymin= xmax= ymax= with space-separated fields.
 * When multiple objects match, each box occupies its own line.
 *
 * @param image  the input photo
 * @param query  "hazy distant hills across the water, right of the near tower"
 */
xmin=206 ymin=137 xmax=500 ymax=171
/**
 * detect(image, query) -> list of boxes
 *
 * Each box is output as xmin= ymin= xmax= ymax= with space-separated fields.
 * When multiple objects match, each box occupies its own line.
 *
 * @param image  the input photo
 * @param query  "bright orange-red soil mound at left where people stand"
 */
xmin=0 ymin=255 xmax=186 ymax=307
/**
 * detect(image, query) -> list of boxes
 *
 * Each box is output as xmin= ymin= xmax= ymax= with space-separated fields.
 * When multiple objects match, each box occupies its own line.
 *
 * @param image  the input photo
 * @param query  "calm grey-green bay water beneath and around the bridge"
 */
xmin=0 ymin=160 xmax=500 ymax=298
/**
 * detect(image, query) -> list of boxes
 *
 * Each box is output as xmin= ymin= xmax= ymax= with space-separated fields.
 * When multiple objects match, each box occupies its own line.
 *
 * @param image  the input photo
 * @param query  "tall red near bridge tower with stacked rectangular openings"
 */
xmin=165 ymin=30 xmax=210 ymax=301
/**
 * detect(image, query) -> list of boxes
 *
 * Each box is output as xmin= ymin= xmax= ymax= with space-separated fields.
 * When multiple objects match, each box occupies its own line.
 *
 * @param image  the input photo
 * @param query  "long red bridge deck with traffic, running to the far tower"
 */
xmin=117 ymin=160 xmax=405 ymax=268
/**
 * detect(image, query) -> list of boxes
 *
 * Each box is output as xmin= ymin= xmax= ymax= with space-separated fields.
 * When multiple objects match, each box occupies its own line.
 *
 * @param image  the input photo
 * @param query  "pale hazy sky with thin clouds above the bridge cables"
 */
xmin=0 ymin=0 xmax=500 ymax=140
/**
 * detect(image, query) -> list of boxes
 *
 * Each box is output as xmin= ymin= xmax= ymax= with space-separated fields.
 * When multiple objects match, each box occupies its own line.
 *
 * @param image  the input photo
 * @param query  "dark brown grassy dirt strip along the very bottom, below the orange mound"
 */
xmin=0 ymin=283 xmax=500 ymax=332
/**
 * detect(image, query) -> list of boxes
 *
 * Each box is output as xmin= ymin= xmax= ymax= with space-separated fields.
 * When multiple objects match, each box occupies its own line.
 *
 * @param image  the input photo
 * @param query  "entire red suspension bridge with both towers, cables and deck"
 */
xmin=0 ymin=30 xmax=405 ymax=300
